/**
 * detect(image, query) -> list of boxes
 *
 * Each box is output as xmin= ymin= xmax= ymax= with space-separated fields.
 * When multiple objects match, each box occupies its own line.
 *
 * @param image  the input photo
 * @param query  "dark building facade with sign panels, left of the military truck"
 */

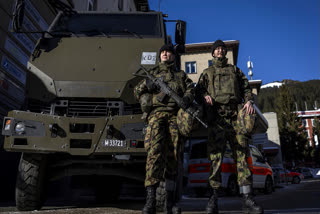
xmin=0 ymin=0 xmax=56 ymax=130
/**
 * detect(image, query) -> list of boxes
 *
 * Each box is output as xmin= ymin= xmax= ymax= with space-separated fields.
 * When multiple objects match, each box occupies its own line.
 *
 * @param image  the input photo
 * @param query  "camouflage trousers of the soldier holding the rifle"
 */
xmin=144 ymin=112 xmax=181 ymax=187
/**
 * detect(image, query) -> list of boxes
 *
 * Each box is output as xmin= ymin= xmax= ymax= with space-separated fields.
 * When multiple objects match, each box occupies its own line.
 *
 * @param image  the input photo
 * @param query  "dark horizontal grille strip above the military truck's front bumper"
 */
xmin=28 ymin=100 xmax=141 ymax=118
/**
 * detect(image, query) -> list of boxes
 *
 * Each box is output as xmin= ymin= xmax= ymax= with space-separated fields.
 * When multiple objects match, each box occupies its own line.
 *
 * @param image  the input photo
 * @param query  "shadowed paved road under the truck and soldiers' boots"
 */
xmin=0 ymin=180 xmax=320 ymax=214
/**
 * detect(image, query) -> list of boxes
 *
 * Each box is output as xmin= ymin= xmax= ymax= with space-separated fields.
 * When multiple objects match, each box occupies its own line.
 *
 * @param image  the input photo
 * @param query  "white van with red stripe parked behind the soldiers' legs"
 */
xmin=187 ymin=139 xmax=274 ymax=195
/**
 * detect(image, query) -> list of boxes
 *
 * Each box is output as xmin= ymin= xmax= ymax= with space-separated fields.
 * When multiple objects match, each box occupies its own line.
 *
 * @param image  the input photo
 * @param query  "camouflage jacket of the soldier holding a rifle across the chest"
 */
xmin=134 ymin=63 xmax=194 ymax=112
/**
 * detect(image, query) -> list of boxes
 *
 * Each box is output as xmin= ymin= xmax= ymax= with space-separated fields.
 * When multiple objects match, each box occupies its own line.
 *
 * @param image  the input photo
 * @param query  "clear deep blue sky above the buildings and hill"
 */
xmin=149 ymin=0 xmax=320 ymax=84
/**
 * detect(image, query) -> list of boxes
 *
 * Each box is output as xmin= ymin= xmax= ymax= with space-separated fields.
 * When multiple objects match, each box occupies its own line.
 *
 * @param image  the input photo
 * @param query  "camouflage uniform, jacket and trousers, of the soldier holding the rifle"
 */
xmin=134 ymin=63 xmax=193 ymax=187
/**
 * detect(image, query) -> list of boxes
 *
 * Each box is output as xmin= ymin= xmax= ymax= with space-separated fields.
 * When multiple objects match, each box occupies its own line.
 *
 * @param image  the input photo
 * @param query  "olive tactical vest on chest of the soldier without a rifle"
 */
xmin=203 ymin=65 xmax=241 ymax=104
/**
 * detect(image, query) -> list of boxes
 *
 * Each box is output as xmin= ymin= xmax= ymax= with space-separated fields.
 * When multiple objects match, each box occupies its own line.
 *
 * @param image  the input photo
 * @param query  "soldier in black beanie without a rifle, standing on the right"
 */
xmin=196 ymin=40 xmax=263 ymax=214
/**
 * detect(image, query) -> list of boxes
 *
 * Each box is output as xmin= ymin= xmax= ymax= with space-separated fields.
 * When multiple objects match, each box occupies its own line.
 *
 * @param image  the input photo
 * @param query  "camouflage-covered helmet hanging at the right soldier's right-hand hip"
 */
xmin=237 ymin=109 xmax=257 ymax=135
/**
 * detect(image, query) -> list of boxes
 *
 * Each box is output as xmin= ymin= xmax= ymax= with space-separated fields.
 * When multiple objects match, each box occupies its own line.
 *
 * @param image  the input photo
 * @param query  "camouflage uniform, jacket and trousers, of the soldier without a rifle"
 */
xmin=196 ymin=58 xmax=253 ymax=189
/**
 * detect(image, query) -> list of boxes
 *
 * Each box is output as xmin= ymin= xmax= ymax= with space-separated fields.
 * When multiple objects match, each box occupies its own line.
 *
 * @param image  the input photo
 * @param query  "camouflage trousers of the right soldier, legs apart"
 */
xmin=207 ymin=115 xmax=252 ymax=189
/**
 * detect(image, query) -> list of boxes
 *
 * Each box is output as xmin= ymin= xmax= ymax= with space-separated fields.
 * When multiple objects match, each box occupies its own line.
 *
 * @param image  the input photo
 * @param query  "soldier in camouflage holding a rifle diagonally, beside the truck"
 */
xmin=134 ymin=45 xmax=194 ymax=214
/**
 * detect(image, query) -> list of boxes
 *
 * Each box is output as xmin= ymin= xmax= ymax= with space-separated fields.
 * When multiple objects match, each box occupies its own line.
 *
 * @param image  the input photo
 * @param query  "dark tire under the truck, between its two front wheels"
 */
xmin=94 ymin=176 xmax=122 ymax=204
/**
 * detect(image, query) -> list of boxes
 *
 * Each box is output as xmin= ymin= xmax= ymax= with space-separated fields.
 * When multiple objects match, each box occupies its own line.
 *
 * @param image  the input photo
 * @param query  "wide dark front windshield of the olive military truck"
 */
xmin=50 ymin=13 xmax=162 ymax=38
